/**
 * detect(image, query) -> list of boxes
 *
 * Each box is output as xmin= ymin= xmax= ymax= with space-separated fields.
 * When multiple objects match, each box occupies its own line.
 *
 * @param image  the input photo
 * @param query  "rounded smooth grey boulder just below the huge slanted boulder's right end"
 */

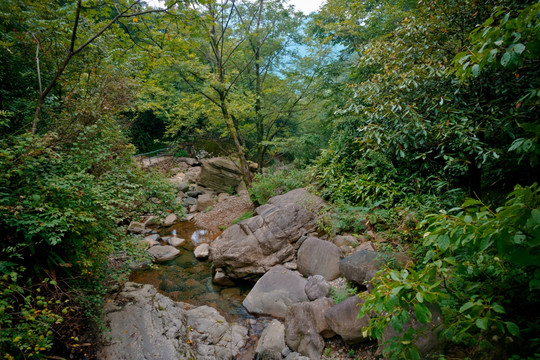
xmin=296 ymin=236 xmax=341 ymax=281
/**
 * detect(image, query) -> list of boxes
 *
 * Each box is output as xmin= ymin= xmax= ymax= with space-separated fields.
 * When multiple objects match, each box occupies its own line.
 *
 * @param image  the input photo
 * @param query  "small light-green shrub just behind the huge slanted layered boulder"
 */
xmin=249 ymin=168 xmax=311 ymax=205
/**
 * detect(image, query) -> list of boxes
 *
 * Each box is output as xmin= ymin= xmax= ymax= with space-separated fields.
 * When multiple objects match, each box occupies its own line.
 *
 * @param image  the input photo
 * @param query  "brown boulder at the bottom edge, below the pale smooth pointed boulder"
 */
xmin=285 ymin=298 xmax=334 ymax=360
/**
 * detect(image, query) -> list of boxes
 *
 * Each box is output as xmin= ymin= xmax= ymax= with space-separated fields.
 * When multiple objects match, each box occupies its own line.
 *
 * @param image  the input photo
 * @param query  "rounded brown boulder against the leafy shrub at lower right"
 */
xmin=324 ymin=295 xmax=369 ymax=344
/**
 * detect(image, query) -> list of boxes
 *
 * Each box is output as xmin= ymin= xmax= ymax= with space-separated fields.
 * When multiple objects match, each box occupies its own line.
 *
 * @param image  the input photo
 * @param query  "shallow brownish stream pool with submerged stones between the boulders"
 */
xmin=130 ymin=221 xmax=252 ymax=320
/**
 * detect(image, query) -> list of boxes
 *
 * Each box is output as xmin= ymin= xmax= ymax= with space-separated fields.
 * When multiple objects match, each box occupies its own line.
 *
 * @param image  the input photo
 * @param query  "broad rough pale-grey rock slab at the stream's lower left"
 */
xmin=98 ymin=282 xmax=247 ymax=360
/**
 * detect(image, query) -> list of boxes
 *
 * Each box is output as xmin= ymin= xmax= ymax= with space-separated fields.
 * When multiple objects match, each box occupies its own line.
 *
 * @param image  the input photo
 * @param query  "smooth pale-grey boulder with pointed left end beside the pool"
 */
xmin=242 ymin=266 xmax=308 ymax=319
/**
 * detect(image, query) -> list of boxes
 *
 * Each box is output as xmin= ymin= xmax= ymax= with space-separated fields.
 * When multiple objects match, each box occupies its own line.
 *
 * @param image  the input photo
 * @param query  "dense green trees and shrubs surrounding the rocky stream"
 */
xmin=0 ymin=0 xmax=540 ymax=358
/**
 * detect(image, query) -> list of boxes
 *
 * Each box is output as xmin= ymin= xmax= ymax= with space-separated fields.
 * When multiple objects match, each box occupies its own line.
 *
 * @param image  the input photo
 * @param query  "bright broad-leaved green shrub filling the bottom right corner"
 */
xmin=360 ymin=184 xmax=540 ymax=358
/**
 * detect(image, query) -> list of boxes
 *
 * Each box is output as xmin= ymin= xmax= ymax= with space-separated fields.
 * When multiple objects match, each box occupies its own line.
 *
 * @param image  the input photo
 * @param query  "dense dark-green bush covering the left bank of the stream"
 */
xmin=0 ymin=119 xmax=180 ymax=358
